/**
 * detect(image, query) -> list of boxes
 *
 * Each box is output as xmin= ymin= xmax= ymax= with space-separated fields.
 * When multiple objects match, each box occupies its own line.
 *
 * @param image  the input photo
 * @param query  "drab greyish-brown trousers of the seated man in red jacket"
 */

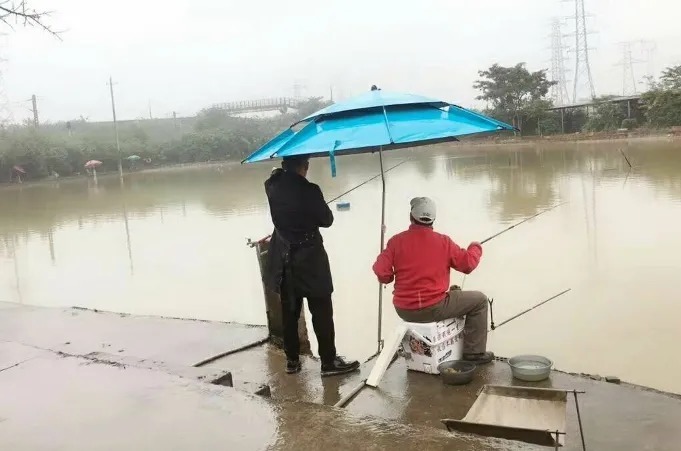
xmin=395 ymin=287 xmax=488 ymax=354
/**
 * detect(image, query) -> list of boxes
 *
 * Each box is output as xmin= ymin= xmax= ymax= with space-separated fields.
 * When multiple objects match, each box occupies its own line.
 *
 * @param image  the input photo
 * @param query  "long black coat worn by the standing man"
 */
xmin=265 ymin=169 xmax=333 ymax=297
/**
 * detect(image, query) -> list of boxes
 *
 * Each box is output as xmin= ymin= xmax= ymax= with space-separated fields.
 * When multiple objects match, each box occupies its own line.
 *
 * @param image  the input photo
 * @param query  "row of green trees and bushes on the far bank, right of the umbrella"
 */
xmin=473 ymin=63 xmax=681 ymax=135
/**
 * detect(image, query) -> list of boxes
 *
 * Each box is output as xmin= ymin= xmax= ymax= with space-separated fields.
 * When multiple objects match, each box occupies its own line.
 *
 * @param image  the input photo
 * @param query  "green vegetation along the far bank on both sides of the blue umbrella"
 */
xmin=0 ymin=63 xmax=681 ymax=184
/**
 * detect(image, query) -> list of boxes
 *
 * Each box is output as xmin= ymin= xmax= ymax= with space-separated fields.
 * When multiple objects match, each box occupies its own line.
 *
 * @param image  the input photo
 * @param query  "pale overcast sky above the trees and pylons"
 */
xmin=0 ymin=0 xmax=681 ymax=121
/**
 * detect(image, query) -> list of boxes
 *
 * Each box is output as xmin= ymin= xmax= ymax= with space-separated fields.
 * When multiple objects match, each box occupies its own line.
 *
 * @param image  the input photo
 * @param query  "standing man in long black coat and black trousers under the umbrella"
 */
xmin=265 ymin=156 xmax=359 ymax=376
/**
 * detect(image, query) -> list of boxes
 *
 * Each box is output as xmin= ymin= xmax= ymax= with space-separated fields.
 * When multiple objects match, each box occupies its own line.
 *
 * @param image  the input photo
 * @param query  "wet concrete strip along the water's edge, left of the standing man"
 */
xmin=0 ymin=303 xmax=268 ymax=366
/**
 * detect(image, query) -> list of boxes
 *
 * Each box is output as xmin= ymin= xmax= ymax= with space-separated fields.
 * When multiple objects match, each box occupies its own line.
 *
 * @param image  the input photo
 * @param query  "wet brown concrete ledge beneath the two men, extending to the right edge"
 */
xmin=212 ymin=347 xmax=681 ymax=451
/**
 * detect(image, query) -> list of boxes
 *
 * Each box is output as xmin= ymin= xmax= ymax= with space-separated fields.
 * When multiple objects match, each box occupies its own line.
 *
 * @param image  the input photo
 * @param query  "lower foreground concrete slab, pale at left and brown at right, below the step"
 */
xmin=0 ymin=343 xmax=494 ymax=451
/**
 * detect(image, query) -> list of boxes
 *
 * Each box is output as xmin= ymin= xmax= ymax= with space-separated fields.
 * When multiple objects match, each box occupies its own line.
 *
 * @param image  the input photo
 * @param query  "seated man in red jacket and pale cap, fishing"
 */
xmin=373 ymin=197 xmax=494 ymax=363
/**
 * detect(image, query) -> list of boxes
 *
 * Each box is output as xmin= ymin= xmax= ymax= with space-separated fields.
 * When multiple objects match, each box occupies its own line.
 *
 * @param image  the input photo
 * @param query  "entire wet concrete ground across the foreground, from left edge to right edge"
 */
xmin=0 ymin=304 xmax=681 ymax=451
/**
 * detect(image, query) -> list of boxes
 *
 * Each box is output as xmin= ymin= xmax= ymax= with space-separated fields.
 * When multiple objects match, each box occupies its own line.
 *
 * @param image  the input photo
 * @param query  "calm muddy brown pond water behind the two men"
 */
xmin=0 ymin=139 xmax=681 ymax=393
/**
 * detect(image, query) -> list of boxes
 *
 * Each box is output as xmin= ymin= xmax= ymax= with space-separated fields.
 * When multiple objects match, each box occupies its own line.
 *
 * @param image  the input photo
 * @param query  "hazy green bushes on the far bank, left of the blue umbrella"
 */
xmin=0 ymin=98 xmax=328 ymax=181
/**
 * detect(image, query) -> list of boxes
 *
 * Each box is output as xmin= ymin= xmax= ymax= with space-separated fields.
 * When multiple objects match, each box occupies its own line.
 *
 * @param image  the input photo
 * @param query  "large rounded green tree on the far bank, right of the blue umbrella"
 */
xmin=473 ymin=63 xmax=555 ymax=133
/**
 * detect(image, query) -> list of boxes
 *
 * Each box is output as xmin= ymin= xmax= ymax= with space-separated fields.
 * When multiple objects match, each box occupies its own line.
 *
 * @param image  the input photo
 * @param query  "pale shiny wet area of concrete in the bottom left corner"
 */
xmin=0 ymin=355 xmax=278 ymax=451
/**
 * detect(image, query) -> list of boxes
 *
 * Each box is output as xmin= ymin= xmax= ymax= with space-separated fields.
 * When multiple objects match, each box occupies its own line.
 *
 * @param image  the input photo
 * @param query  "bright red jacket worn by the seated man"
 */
xmin=373 ymin=224 xmax=482 ymax=310
